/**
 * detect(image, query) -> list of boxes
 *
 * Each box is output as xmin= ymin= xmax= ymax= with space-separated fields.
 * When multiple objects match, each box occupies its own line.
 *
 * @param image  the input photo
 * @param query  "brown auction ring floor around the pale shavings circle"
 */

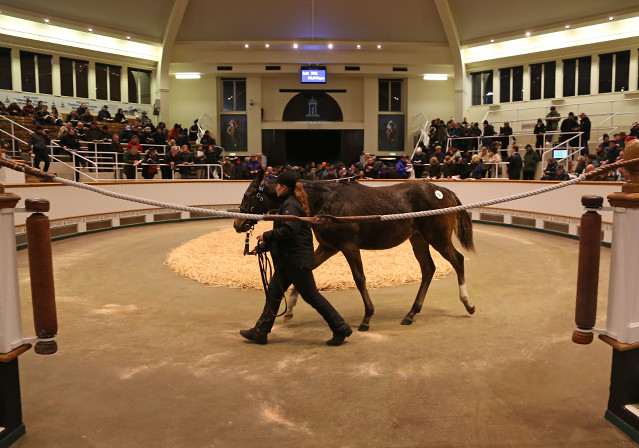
xmin=14 ymin=220 xmax=635 ymax=448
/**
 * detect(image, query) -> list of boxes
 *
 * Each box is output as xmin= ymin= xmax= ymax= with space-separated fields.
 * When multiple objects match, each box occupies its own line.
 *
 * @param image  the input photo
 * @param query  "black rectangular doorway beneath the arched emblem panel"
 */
xmin=286 ymin=130 xmax=342 ymax=165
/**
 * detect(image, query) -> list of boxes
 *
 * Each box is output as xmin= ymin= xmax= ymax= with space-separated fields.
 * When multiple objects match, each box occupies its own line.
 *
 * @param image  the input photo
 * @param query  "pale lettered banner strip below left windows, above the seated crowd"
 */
xmin=0 ymin=90 xmax=153 ymax=118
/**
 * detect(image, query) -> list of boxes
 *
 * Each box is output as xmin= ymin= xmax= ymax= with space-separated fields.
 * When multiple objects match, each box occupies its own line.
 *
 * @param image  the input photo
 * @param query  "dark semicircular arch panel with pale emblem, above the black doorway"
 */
xmin=282 ymin=91 xmax=344 ymax=121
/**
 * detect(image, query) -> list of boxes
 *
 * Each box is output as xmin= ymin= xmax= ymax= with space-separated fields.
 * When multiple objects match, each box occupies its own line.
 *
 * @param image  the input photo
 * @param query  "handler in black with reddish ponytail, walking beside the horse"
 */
xmin=240 ymin=171 xmax=353 ymax=346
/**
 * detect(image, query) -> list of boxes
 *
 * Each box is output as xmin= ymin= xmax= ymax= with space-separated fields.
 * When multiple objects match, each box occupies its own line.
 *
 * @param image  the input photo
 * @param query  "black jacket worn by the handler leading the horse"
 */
xmin=264 ymin=193 xmax=313 ymax=269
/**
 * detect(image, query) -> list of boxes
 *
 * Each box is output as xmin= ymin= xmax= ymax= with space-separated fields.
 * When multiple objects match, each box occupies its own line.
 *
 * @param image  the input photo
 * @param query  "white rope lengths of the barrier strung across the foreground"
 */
xmin=48 ymin=174 xmax=586 ymax=221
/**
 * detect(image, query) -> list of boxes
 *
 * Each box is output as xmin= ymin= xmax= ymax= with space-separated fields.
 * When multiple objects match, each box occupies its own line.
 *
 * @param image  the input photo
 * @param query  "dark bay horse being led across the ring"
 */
xmin=233 ymin=174 xmax=475 ymax=331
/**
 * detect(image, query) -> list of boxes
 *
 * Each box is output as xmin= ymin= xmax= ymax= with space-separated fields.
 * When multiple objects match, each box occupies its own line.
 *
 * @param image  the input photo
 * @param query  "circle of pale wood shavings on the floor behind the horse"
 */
xmin=165 ymin=221 xmax=453 ymax=291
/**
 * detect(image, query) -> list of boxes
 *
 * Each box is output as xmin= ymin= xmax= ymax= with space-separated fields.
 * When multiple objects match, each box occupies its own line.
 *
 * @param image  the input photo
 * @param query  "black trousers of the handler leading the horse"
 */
xmin=255 ymin=267 xmax=350 ymax=334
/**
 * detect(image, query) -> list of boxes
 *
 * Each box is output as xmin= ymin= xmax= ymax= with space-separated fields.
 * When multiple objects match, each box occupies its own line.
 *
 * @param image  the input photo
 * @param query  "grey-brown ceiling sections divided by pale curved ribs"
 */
xmin=0 ymin=0 xmax=639 ymax=51
